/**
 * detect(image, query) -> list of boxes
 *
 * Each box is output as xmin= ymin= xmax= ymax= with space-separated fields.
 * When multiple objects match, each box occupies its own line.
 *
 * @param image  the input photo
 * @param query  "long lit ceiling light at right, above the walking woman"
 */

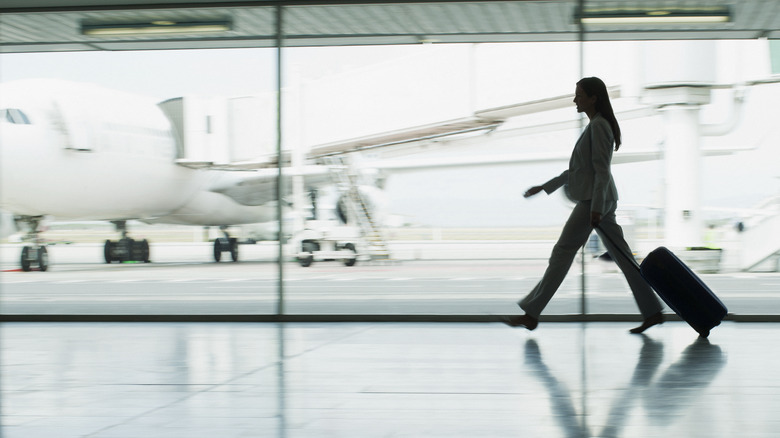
xmin=579 ymin=7 xmax=731 ymax=24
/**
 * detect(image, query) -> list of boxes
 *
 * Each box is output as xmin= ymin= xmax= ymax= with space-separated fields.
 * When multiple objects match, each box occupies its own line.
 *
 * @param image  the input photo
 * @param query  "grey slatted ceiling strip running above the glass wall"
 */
xmin=0 ymin=0 xmax=780 ymax=53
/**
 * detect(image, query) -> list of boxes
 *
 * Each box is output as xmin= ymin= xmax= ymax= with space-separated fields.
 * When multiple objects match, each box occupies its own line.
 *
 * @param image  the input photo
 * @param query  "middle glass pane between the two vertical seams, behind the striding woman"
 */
xmin=285 ymin=43 xmax=581 ymax=315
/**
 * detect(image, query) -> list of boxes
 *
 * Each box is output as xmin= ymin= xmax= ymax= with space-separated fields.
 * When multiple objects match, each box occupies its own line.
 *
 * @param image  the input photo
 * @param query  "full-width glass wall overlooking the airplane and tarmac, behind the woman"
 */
xmin=0 ymin=3 xmax=780 ymax=319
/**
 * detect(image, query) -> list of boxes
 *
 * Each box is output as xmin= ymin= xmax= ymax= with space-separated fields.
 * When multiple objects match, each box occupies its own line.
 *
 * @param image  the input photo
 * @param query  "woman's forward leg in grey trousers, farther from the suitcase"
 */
xmin=518 ymin=201 xmax=593 ymax=319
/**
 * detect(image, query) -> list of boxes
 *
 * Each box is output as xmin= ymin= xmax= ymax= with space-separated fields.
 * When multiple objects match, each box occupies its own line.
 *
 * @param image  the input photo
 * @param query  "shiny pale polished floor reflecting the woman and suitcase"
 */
xmin=0 ymin=322 xmax=780 ymax=438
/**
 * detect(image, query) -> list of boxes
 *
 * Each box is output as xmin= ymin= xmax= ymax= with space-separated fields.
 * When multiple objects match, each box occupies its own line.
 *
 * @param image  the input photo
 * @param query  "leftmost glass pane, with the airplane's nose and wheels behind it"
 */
xmin=0 ymin=49 xmax=278 ymax=315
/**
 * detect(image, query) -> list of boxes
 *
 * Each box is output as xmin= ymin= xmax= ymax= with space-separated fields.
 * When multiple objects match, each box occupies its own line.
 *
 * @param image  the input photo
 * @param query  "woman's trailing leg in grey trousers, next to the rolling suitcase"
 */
xmin=596 ymin=201 xmax=663 ymax=319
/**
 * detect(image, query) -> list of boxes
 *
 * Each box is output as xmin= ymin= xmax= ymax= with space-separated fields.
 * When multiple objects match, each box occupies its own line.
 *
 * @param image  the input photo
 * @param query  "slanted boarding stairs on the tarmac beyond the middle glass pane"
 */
xmin=322 ymin=155 xmax=391 ymax=260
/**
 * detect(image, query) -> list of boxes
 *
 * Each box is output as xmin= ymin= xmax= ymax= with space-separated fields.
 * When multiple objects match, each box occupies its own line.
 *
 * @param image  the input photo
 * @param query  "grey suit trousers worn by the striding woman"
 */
xmin=518 ymin=201 xmax=663 ymax=319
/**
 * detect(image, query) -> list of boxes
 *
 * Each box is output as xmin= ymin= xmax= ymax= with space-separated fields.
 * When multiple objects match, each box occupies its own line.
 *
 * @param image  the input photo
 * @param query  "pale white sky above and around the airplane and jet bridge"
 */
xmin=0 ymin=41 xmax=780 ymax=227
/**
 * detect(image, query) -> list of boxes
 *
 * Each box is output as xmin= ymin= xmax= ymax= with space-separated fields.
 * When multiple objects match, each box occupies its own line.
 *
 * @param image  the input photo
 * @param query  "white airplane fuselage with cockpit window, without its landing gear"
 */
xmin=0 ymin=80 xmax=275 ymax=226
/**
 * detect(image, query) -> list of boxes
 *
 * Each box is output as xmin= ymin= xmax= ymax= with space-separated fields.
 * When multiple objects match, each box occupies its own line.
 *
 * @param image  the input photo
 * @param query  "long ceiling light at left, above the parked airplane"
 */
xmin=81 ymin=20 xmax=232 ymax=36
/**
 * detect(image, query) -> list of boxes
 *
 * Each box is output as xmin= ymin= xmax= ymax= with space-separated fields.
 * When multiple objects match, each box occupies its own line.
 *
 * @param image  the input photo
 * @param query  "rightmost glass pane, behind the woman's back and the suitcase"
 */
xmin=584 ymin=40 xmax=780 ymax=314
